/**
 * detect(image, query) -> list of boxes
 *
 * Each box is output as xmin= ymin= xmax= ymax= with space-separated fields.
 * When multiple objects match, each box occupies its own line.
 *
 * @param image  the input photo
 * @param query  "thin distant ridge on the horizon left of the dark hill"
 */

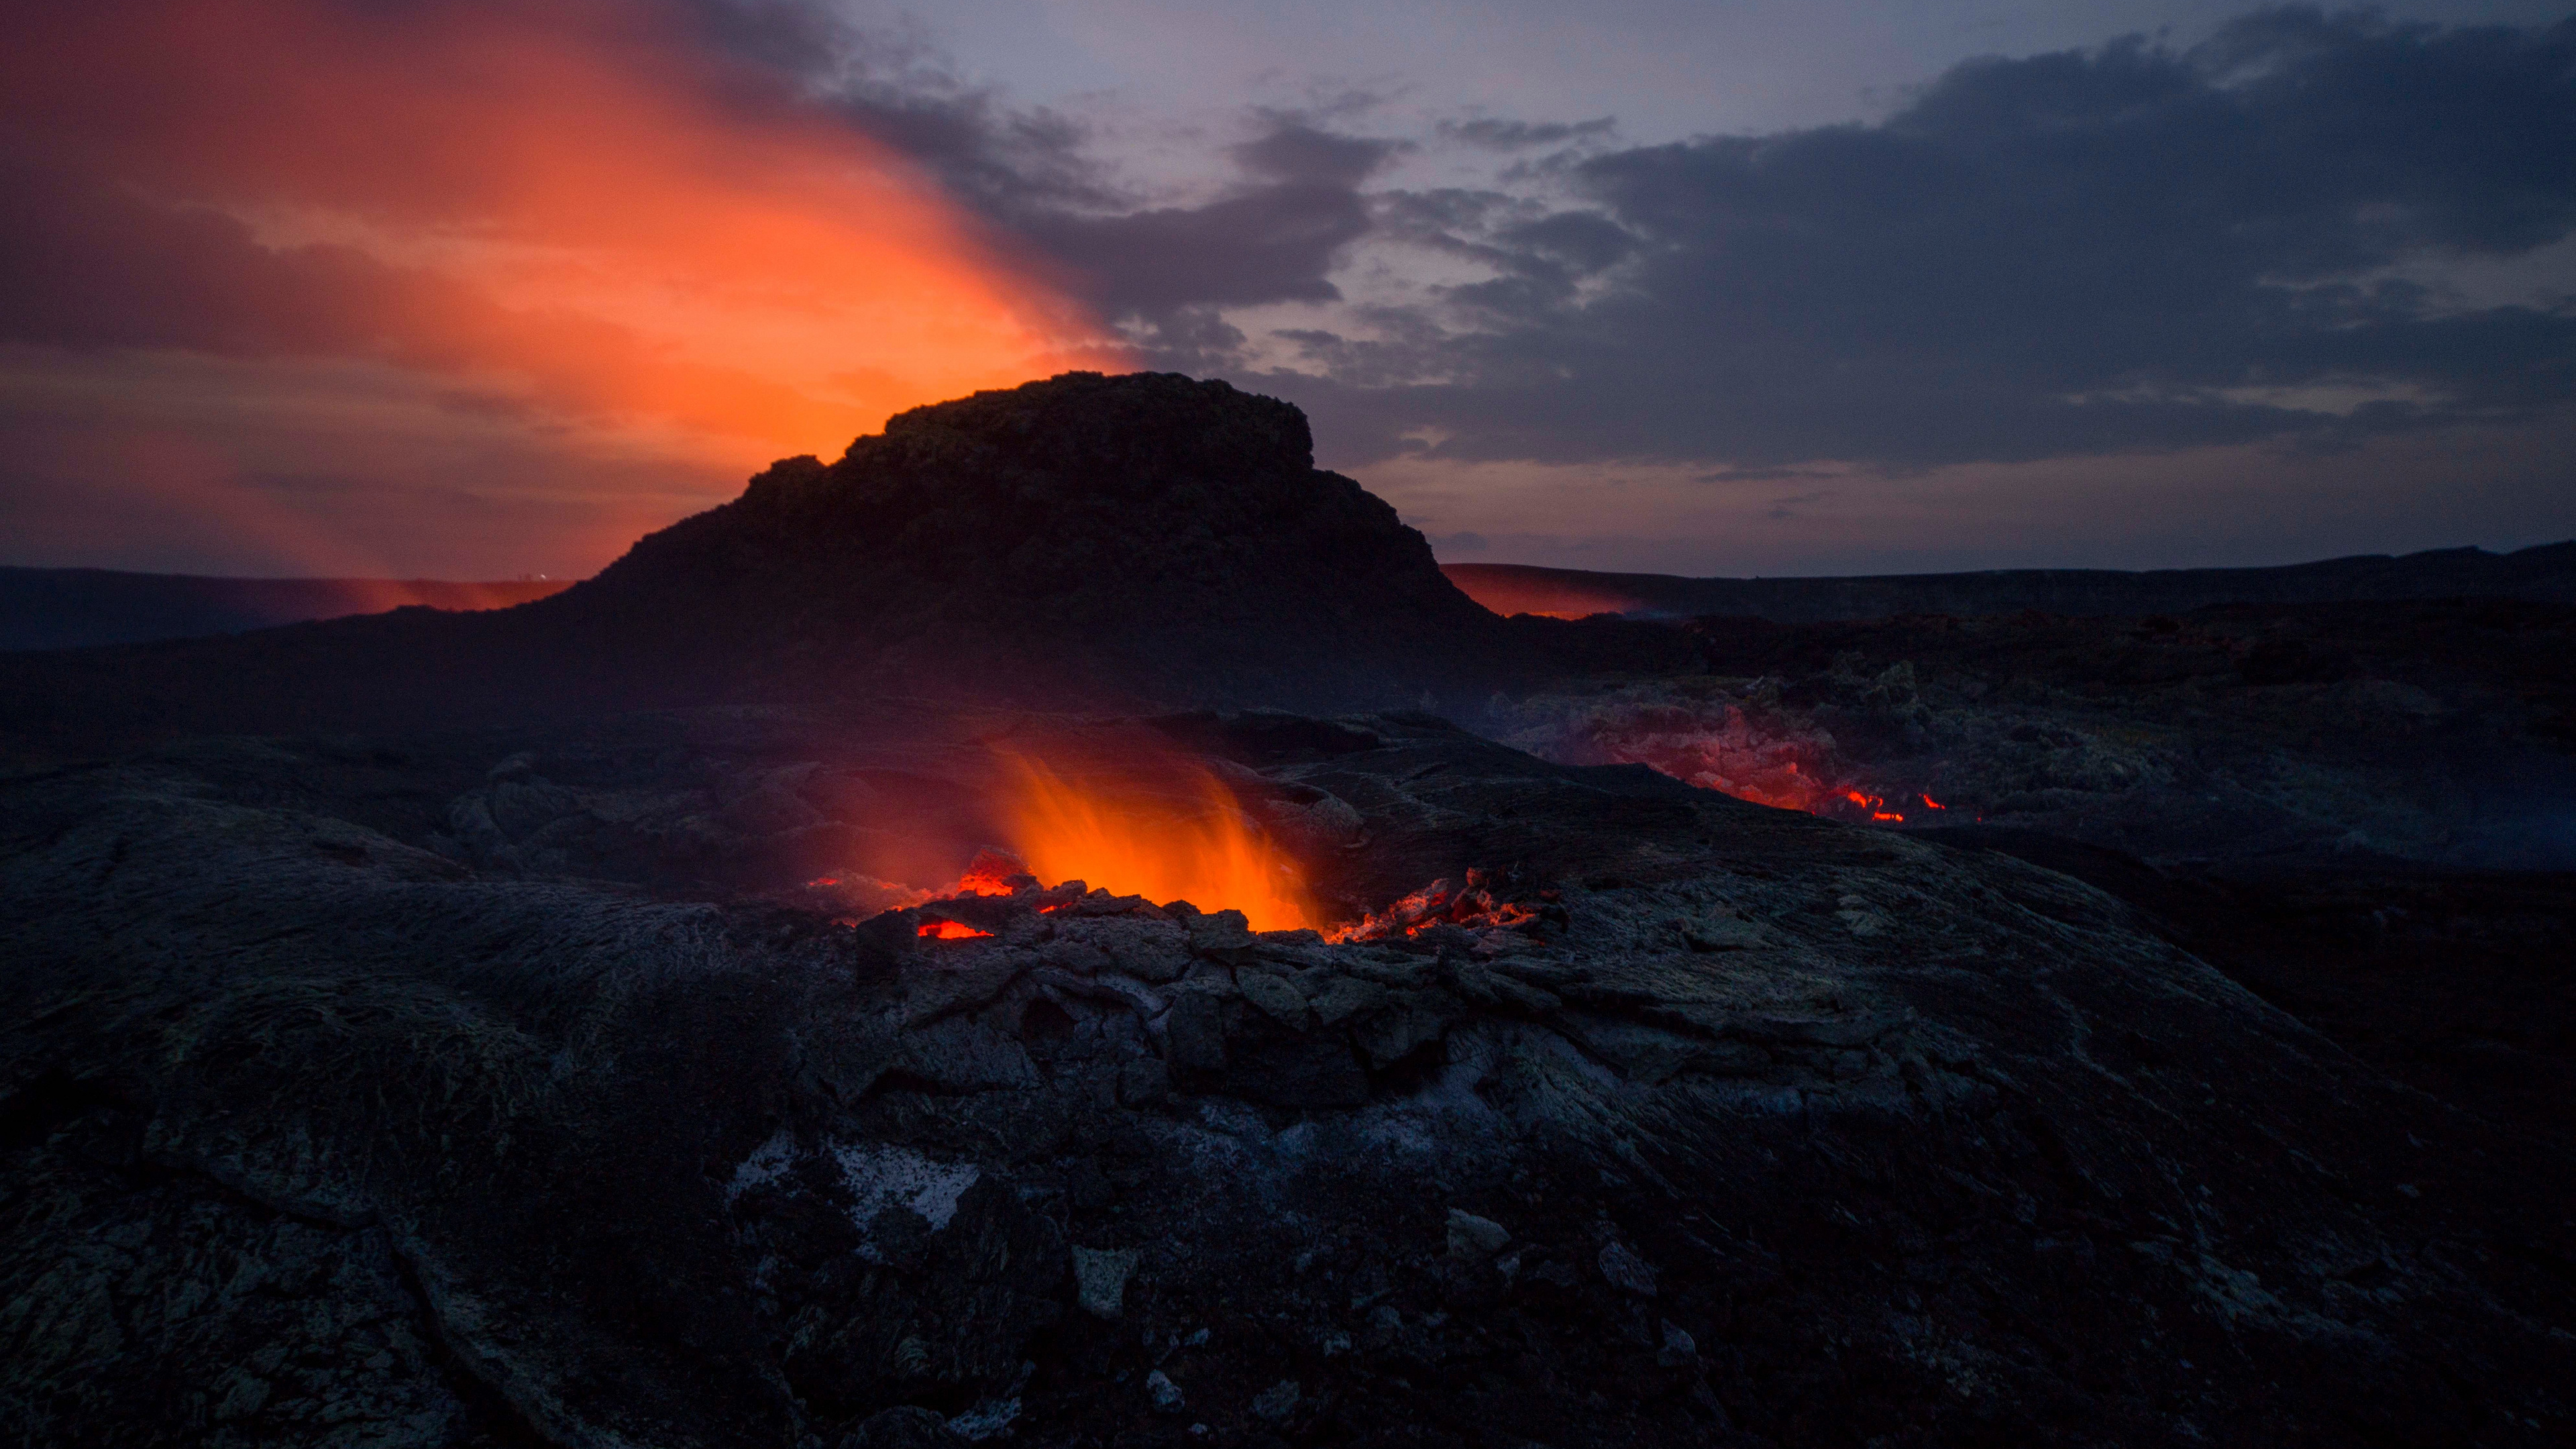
xmin=0 ymin=568 xmax=574 ymax=650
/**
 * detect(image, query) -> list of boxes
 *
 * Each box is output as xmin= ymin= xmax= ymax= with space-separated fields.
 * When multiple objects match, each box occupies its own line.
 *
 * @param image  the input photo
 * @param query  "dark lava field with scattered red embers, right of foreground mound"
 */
xmin=1489 ymin=598 xmax=2576 ymax=1165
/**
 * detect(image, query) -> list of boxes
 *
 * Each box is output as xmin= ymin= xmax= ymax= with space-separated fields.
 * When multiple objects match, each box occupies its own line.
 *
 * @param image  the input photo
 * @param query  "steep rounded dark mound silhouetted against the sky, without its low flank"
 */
xmin=551 ymin=374 xmax=1499 ymax=696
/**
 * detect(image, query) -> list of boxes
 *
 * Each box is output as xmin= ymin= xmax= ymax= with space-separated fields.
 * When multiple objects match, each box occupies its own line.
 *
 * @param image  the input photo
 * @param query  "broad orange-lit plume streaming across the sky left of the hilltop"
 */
xmin=0 ymin=0 xmax=1128 ymax=564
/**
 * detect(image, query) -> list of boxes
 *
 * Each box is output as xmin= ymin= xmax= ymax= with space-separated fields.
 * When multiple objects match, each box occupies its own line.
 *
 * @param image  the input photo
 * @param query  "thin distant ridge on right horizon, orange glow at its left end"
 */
xmin=1440 ymin=541 xmax=2576 ymax=613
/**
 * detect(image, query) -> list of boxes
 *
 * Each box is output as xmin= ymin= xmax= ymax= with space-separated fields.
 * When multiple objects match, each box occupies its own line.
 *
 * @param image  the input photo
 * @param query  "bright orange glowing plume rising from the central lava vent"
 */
xmin=973 ymin=753 xmax=1319 ymax=930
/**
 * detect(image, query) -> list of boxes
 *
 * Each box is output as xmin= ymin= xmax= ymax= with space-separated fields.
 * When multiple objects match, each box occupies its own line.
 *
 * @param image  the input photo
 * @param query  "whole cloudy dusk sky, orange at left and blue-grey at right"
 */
xmin=0 ymin=0 xmax=2576 ymax=578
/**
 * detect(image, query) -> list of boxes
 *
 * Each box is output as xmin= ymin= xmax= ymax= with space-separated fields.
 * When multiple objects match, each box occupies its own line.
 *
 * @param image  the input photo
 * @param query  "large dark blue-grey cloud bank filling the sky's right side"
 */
xmin=1263 ymin=8 xmax=2576 ymax=467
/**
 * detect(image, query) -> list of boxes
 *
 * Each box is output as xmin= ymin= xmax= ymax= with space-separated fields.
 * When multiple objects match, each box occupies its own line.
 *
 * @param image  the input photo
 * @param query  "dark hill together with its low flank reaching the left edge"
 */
xmin=0 ymin=374 xmax=1566 ymax=753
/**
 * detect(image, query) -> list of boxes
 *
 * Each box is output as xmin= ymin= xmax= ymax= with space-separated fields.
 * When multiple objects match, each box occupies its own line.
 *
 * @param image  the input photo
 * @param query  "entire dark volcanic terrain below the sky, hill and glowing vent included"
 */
xmin=0 ymin=374 xmax=2576 ymax=1449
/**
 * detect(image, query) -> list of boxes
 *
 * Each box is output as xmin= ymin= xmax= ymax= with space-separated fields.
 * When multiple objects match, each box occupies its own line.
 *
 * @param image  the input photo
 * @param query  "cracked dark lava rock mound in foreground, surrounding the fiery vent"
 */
xmin=0 ymin=706 xmax=2576 ymax=1449
